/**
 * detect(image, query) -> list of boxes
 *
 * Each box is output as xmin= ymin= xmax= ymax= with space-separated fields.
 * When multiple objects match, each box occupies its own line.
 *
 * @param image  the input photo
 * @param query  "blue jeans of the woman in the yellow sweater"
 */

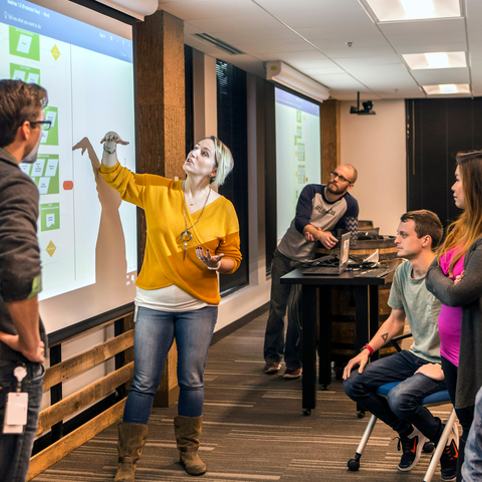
xmin=123 ymin=306 xmax=218 ymax=425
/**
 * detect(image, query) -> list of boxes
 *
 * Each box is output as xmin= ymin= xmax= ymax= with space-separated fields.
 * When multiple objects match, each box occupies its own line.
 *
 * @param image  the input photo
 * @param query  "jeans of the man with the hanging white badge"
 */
xmin=0 ymin=360 xmax=44 ymax=482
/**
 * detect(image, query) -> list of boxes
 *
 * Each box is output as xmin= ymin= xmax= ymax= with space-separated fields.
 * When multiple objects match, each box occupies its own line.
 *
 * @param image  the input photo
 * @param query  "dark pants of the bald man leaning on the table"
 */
xmin=264 ymin=250 xmax=302 ymax=368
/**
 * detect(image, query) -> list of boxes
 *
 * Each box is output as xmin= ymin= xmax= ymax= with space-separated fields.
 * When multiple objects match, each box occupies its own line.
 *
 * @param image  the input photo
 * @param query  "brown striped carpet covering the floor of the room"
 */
xmin=33 ymin=314 xmax=451 ymax=482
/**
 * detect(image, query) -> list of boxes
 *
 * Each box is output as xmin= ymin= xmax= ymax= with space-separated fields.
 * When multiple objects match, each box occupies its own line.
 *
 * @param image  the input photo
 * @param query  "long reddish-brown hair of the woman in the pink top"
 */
xmin=437 ymin=151 xmax=482 ymax=276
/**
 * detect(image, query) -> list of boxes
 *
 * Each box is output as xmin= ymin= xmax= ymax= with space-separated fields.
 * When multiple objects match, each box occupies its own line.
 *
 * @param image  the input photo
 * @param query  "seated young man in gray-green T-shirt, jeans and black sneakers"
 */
xmin=343 ymin=210 xmax=458 ymax=480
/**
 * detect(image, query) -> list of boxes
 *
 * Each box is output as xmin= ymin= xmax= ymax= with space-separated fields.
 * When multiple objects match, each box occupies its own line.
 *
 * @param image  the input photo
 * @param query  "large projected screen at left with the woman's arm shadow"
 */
xmin=0 ymin=0 xmax=137 ymax=328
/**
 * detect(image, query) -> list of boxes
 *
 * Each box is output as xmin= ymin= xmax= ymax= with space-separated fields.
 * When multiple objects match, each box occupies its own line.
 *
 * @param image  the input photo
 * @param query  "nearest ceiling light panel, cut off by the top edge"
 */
xmin=359 ymin=0 xmax=460 ymax=22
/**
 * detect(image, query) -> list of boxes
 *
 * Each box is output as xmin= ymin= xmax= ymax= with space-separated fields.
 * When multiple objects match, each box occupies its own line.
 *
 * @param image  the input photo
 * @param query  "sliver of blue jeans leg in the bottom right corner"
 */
xmin=459 ymin=388 xmax=482 ymax=482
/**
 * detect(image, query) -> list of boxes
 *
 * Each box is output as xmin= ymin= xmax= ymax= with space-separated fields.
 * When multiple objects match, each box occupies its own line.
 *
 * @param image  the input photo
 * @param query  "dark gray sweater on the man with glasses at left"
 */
xmin=0 ymin=148 xmax=47 ymax=362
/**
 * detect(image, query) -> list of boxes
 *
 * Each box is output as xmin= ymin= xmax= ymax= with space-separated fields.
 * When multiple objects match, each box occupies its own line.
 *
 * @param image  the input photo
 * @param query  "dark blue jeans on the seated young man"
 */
xmin=343 ymin=350 xmax=446 ymax=443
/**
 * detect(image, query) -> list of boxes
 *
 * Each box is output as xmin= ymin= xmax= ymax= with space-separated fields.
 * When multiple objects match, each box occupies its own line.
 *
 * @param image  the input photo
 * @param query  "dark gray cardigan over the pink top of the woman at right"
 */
xmin=426 ymin=239 xmax=482 ymax=408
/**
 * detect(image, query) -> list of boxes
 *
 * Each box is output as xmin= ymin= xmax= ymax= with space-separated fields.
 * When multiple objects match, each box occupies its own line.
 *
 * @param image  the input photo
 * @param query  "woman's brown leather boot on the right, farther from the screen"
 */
xmin=174 ymin=415 xmax=206 ymax=475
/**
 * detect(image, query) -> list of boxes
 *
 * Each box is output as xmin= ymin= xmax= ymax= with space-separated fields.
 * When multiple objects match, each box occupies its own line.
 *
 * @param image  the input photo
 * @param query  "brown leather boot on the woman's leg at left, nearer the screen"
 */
xmin=114 ymin=422 xmax=147 ymax=482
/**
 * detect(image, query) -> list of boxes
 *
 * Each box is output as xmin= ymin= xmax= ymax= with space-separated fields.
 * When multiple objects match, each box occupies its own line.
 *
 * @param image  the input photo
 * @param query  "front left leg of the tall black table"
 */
xmin=302 ymin=285 xmax=316 ymax=415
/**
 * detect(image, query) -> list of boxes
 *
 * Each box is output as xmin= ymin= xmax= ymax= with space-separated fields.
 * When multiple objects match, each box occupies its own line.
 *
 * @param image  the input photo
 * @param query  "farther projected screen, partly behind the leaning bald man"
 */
xmin=275 ymin=88 xmax=321 ymax=240
